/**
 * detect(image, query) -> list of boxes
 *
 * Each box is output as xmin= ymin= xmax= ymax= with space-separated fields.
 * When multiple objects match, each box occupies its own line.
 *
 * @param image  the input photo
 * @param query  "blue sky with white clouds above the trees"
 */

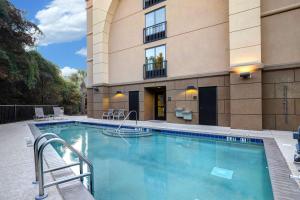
xmin=11 ymin=0 xmax=86 ymax=76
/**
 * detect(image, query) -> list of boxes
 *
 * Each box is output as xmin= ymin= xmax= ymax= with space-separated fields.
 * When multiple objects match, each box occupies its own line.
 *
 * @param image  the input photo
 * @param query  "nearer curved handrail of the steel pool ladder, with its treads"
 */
xmin=35 ymin=137 xmax=94 ymax=200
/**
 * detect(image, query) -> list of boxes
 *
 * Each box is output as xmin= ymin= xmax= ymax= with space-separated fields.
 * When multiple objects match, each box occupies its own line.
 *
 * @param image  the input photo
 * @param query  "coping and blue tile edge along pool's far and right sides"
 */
xmin=33 ymin=120 xmax=300 ymax=200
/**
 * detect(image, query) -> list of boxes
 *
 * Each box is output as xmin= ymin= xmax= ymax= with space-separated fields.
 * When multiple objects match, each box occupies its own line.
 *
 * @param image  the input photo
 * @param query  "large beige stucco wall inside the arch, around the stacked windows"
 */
xmin=108 ymin=0 xmax=229 ymax=84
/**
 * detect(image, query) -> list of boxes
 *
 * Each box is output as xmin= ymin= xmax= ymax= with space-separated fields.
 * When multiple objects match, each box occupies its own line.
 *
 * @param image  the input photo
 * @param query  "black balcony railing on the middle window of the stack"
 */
xmin=144 ymin=22 xmax=167 ymax=43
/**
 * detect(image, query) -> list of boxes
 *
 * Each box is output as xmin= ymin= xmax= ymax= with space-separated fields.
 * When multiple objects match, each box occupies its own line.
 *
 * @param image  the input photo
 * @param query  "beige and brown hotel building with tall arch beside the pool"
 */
xmin=87 ymin=0 xmax=300 ymax=130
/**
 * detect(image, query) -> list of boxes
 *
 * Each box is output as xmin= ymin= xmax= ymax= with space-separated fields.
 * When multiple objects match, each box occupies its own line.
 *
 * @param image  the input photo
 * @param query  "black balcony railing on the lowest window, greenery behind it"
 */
xmin=144 ymin=60 xmax=167 ymax=79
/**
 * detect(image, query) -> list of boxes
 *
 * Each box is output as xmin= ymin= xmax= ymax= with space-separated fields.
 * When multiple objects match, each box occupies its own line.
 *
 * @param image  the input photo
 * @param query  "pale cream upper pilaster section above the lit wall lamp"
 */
xmin=229 ymin=0 xmax=261 ymax=67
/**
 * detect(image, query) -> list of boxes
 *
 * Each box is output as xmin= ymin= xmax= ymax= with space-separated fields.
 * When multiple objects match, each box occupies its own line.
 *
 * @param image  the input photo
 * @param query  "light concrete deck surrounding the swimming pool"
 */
xmin=0 ymin=116 xmax=300 ymax=200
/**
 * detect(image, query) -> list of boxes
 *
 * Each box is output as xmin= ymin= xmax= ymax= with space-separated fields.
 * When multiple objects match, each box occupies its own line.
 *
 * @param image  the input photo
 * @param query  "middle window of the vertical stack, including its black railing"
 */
xmin=144 ymin=7 xmax=167 ymax=43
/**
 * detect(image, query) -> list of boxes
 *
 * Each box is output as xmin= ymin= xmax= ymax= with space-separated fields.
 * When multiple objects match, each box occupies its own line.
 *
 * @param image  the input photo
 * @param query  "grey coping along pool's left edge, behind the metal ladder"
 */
xmin=27 ymin=123 xmax=95 ymax=200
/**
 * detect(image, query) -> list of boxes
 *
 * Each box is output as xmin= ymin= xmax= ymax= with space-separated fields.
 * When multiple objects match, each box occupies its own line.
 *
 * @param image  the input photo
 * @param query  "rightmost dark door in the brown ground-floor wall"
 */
xmin=199 ymin=87 xmax=217 ymax=125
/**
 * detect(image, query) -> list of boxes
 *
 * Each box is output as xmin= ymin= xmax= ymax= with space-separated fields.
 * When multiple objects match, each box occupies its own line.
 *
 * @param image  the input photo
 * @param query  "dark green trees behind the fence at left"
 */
xmin=0 ymin=0 xmax=81 ymax=114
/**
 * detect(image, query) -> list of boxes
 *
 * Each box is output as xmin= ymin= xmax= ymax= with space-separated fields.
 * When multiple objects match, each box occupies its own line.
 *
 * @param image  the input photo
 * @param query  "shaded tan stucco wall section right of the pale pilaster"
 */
xmin=262 ymin=6 xmax=300 ymax=65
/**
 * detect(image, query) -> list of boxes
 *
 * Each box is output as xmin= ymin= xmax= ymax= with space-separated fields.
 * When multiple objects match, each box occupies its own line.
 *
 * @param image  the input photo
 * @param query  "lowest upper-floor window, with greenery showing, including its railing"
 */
xmin=144 ymin=45 xmax=167 ymax=79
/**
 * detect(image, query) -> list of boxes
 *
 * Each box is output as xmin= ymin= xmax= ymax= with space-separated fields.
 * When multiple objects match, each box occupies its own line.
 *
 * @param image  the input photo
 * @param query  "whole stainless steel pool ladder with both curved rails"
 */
xmin=33 ymin=133 xmax=94 ymax=200
